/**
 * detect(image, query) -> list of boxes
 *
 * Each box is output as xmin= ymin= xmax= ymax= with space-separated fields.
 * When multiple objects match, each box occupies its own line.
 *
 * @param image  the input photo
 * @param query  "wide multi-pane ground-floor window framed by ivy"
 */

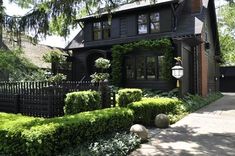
xmin=125 ymin=56 xmax=164 ymax=80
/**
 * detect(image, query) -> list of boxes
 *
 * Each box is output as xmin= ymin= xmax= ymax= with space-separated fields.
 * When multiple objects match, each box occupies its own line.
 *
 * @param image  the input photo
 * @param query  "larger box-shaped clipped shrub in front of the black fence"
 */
xmin=64 ymin=91 xmax=101 ymax=114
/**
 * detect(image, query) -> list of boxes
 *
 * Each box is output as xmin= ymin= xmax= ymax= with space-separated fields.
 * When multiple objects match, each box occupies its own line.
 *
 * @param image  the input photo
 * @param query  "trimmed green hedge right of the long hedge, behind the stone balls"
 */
xmin=128 ymin=98 xmax=182 ymax=125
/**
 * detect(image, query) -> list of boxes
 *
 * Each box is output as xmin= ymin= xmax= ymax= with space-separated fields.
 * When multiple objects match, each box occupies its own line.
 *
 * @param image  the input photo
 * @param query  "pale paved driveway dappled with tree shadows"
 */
xmin=130 ymin=93 xmax=235 ymax=156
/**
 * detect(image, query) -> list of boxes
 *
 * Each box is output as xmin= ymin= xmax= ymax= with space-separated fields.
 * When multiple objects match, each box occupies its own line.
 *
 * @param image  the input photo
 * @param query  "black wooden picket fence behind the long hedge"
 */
xmin=0 ymin=81 xmax=115 ymax=117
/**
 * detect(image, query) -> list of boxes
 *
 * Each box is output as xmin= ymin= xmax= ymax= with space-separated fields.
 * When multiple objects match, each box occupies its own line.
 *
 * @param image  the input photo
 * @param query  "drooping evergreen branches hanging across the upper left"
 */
xmin=0 ymin=0 xmax=157 ymax=44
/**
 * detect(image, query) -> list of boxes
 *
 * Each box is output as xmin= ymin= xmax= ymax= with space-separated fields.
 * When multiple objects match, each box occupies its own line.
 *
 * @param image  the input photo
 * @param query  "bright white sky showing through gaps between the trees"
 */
xmin=3 ymin=0 xmax=229 ymax=48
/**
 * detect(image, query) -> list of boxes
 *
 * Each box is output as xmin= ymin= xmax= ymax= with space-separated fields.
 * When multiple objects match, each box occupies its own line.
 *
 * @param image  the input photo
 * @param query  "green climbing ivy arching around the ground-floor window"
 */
xmin=111 ymin=38 xmax=174 ymax=86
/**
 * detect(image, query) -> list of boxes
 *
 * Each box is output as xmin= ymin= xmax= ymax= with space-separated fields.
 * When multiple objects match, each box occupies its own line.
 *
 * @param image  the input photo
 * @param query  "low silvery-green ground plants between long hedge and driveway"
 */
xmin=62 ymin=132 xmax=141 ymax=156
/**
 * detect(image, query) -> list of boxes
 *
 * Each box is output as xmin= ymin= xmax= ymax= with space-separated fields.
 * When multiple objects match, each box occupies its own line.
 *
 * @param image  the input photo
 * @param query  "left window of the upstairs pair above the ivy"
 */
xmin=138 ymin=14 xmax=148 ymax=34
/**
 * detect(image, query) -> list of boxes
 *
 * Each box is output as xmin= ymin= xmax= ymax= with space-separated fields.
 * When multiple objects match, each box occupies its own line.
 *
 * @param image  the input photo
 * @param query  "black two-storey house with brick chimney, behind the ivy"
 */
xmin=66 ymin=0 xmax=220 ymax=96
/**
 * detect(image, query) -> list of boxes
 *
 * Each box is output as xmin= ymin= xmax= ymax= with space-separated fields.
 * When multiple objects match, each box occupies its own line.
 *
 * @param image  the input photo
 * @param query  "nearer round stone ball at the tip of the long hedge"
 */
xmin=130 ymin=124 xmax=148 ymax=141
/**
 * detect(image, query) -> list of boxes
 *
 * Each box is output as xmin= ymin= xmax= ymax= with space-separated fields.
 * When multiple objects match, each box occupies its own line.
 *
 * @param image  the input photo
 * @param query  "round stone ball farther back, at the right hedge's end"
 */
xmin=154 ymin=114 xmax=170 ymax=128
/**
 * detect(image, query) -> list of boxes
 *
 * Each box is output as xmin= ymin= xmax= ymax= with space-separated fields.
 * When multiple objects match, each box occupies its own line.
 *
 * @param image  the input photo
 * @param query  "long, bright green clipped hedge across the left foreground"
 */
xmin=0 ymin=108 xmax=134 ymax=156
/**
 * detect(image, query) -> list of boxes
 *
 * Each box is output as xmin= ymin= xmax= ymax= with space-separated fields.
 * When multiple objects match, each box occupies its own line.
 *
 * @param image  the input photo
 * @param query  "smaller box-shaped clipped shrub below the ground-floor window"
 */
xmin=118 ymin=88 xmax=142 ymax=107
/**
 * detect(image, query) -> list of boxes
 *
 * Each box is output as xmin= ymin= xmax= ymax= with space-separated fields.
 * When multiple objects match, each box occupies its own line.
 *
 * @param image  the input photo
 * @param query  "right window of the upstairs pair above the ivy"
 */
xmin=150 ymin=12 xmax=160 ymax=33
